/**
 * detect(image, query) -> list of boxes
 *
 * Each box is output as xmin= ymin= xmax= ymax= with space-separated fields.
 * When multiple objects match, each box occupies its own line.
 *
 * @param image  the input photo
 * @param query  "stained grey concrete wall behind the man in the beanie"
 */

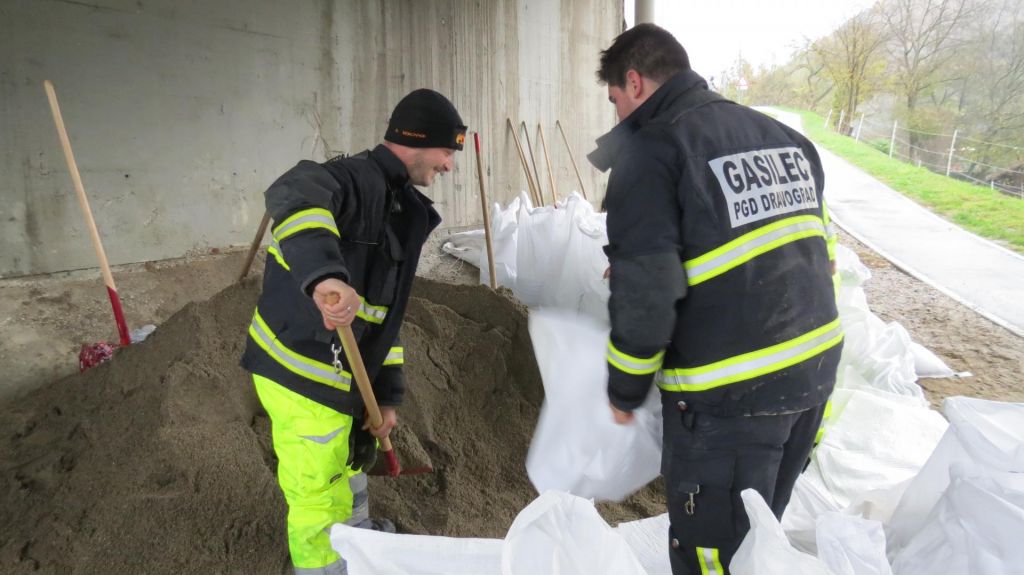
xmin=0 ymin=0 xmax=623 ymax=276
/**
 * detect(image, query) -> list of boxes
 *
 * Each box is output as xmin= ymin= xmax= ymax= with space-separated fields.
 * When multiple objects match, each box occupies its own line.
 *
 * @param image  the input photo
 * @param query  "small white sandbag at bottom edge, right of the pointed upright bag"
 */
xmin=816 ymin=513 xmax=893 ymax=575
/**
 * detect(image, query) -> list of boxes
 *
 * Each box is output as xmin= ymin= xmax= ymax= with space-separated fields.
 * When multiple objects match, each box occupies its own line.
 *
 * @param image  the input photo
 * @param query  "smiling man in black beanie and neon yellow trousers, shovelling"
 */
xmin=242 ymin=89 xmax=466 ymax=575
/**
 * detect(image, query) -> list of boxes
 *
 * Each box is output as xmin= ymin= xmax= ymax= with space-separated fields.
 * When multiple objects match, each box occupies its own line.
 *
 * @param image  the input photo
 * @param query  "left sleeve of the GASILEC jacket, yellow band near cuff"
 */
xmin=605 ymin=130 xmax=686 ymax=411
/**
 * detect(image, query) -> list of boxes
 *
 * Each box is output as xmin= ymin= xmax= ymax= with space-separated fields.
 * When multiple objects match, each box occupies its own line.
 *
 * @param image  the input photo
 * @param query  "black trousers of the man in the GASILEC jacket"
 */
xmin=662 ymin=401 xmax=824 ymax=575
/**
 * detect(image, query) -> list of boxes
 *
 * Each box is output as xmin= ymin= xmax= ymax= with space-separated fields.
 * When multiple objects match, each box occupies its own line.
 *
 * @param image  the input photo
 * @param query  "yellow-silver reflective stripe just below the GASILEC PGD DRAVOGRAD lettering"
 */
xmin=683 ymin=216 xmax=825 ymax=285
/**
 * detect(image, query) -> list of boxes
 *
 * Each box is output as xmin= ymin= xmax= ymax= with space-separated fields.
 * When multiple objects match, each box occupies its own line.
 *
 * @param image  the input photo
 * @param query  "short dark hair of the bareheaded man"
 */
xmin=597 ymin=24 xmax=690 ymax=87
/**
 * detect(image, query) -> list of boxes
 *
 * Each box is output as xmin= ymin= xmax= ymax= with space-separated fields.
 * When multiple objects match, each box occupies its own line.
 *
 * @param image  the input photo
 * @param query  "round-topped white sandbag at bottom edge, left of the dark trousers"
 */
xmin=501 ymin=491 xmax=646 ymax=575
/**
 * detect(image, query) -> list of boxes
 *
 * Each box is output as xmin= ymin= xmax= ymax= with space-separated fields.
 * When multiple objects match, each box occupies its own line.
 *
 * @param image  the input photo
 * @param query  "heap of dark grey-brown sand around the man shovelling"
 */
xmin=0 ymin=279 xmax=659 ymax=574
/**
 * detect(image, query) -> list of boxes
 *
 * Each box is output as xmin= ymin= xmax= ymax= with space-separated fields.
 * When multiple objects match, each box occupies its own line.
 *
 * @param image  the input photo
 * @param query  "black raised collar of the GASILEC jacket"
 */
xmin=587 ymin=70 xmax=708 ymax=172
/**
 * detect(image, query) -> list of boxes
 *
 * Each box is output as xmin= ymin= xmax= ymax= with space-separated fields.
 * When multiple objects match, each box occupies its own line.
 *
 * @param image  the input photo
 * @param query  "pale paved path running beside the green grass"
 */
xmin=771 ymin=109 xmax=1024 ymax=337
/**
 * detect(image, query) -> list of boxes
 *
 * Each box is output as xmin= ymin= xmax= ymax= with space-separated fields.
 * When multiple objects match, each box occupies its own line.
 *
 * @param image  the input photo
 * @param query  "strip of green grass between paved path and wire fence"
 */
xmin=787 ymin=109 xmax=1024 ymax=254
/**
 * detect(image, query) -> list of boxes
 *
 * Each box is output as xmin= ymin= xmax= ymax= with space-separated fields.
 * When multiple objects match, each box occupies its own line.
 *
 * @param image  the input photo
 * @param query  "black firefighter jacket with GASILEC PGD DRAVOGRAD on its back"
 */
xmin=590 ymin=71 xmax=843 ymax=415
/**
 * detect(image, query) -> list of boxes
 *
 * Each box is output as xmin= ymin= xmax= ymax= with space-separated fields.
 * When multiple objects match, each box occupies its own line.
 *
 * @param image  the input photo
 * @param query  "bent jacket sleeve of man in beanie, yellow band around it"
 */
xmin=264 ymin=161 xmax=354 ymax=295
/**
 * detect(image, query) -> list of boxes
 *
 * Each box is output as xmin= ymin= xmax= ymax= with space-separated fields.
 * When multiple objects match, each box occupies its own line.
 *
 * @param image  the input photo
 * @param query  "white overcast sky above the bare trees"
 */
xmin=625 ymin=0 xmax=874 ymax=78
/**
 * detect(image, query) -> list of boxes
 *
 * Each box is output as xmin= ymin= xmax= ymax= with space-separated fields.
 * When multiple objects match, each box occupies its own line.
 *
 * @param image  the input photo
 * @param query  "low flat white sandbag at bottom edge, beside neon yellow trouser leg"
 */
xmin=331 ymin=524 xmax=504 ymax=575
